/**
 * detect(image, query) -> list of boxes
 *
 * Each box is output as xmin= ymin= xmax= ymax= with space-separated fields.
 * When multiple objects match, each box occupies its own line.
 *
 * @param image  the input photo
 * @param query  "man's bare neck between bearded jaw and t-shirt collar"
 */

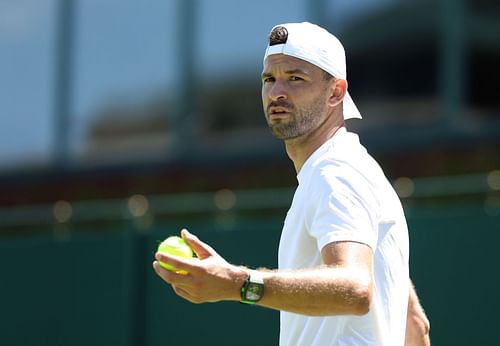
xmin=285 ymin=123 xmax=344 ymax=174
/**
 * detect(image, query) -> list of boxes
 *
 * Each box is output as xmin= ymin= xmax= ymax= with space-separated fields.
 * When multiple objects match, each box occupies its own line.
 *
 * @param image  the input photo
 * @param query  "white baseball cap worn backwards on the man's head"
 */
xmin=264 ymin=22 xmax=361 ymax=119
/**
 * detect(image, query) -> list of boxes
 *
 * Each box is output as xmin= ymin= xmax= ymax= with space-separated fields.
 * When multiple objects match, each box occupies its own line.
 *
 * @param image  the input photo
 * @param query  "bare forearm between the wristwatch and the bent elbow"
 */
xmin=254 ymin=266 xmax=372 ymax=316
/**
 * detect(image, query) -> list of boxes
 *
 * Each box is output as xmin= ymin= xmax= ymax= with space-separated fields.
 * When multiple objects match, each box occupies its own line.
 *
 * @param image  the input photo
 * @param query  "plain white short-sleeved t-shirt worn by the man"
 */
xmin=279 ymin=128 xmax=409 ymax=346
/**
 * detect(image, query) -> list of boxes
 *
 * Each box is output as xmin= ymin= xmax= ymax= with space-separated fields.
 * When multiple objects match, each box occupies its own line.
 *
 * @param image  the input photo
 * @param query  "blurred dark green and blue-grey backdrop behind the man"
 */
xmin=0 ymin=0 xmax=500 ymax=346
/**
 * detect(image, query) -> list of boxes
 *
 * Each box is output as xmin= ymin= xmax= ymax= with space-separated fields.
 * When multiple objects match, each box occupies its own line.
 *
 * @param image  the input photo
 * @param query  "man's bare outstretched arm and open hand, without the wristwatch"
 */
xmin=153 ymin=230 xmax=373 ymax=316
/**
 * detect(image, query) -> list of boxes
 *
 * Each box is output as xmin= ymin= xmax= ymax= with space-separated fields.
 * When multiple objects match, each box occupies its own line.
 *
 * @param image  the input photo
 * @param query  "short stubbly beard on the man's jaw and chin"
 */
xmin=266 ymin=95 xmax=326 ymax=140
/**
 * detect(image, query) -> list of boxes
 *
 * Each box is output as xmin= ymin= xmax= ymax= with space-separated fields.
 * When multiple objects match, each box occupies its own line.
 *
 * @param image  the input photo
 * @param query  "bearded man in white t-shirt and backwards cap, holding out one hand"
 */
xmin=154 ymin=23 xmax=428 ymax=346
